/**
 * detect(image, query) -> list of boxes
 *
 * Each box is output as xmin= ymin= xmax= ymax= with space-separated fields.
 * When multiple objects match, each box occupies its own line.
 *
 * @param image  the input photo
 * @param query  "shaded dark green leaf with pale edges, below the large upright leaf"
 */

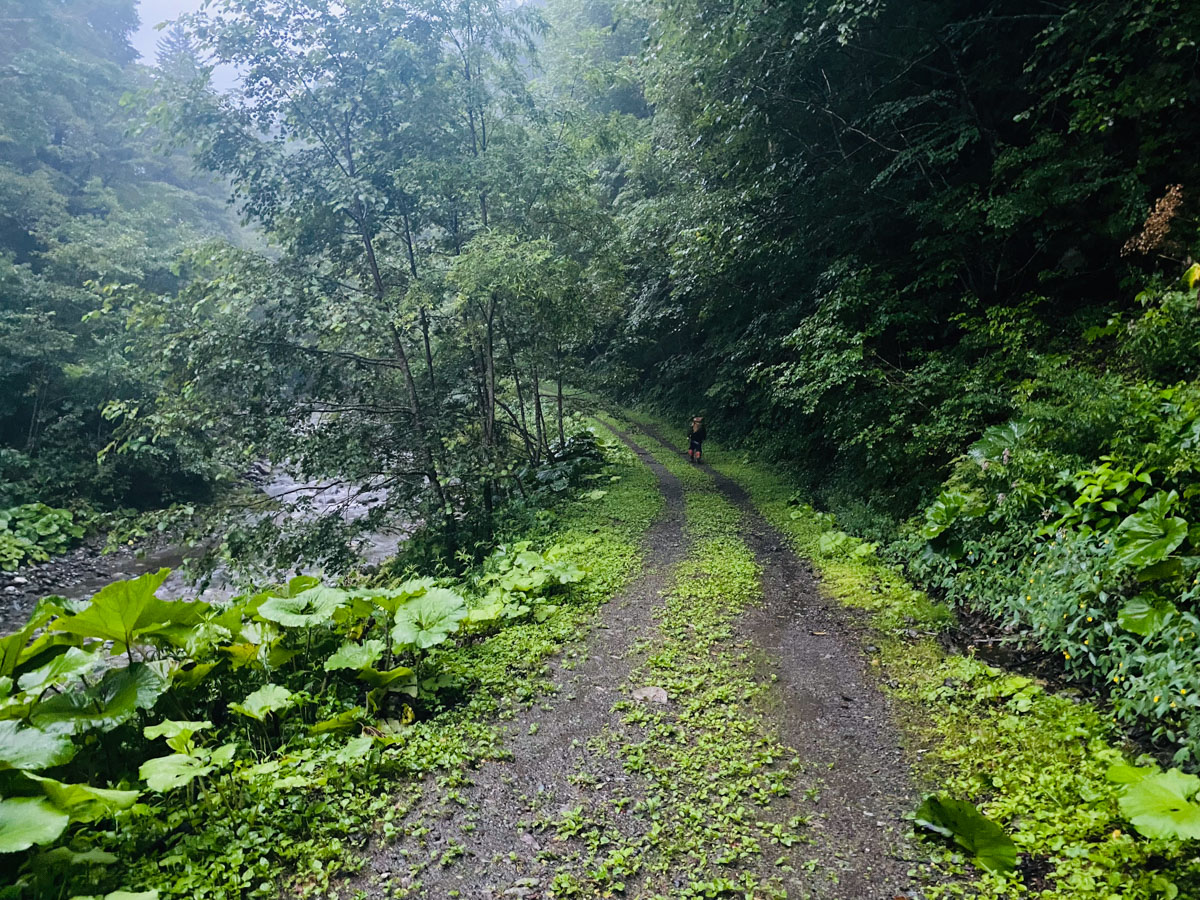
xmin=30 ymin=662 xmax=167 ymax=734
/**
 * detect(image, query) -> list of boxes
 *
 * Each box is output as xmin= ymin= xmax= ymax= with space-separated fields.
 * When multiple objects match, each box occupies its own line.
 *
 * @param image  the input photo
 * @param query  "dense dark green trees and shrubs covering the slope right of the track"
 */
xmin=592 ymin=0 xmax=1200 ymax=763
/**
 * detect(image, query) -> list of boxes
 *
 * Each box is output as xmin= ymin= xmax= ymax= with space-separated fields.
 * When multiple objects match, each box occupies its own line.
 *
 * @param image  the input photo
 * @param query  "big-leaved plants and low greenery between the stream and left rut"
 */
xmin=0 ymin=427 xmax=658 ymax=898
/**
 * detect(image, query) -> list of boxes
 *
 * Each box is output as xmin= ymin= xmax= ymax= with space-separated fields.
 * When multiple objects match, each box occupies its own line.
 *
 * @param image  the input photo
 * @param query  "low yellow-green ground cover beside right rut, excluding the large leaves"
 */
xmin=619 ymin=416 xmax=1200 ymax=900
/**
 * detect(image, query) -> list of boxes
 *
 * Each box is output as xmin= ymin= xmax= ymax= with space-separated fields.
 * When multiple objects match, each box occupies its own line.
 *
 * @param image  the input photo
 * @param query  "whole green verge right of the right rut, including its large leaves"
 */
xmin=634 ymin=415 xmax=1200 ymax=900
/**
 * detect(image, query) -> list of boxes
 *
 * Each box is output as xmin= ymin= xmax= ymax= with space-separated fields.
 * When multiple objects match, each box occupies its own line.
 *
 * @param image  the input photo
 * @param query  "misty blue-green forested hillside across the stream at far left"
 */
xmin=0 ymin=0 xmax=243 ymax=506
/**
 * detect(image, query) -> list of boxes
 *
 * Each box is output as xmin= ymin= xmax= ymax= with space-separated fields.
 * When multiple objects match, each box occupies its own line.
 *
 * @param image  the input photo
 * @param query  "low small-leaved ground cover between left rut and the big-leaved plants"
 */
xmin=0 ymin=427 xmax=662 ymax=900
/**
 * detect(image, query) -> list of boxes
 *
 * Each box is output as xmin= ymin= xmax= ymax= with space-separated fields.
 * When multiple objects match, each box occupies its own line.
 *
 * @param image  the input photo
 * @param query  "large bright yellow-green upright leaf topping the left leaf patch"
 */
xmin=53 ymin=569 xmax=211 ymax=653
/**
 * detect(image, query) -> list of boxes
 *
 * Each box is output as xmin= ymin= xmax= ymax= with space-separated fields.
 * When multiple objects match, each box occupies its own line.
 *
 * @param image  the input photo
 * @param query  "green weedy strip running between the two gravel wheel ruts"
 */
xmin=542 ymin=420 xmax=805 ymax=899
